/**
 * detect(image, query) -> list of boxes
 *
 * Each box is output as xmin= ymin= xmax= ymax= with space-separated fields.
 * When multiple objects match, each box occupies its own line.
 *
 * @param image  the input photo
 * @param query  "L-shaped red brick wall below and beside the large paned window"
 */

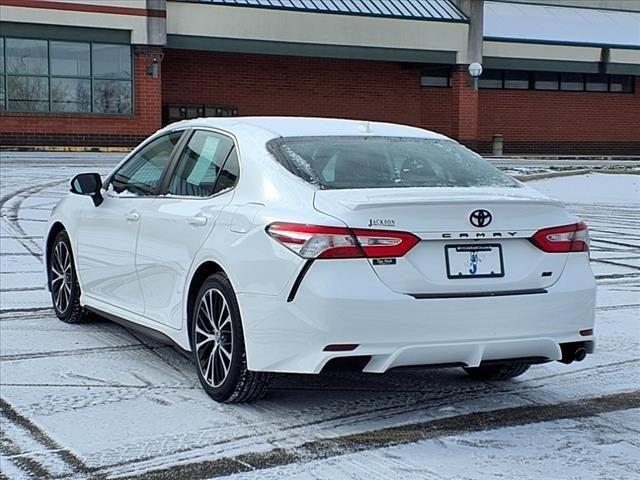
xmin=0 ymin=52 xmax=162 ymax=146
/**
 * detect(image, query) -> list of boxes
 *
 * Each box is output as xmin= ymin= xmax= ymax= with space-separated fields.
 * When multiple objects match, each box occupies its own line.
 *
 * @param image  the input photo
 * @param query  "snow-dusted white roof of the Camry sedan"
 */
xmin=163 ymin=117 xmax=447 ymax=140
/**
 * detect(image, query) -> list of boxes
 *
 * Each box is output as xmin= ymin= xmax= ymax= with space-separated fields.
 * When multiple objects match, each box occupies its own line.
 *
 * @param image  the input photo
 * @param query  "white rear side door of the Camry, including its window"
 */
xmin=136 ymin=130 xmax=238 ymax=328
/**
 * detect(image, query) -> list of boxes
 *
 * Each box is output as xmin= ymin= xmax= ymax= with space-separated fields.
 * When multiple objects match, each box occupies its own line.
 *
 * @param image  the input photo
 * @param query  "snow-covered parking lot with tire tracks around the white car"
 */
xmin=0 ymin=152 xmax=640 ymax=480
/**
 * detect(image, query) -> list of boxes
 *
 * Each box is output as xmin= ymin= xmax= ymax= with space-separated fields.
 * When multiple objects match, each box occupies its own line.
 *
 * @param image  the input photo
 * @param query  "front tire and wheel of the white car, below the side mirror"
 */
xmin=47 ymin=230 xmax=88 ymax=323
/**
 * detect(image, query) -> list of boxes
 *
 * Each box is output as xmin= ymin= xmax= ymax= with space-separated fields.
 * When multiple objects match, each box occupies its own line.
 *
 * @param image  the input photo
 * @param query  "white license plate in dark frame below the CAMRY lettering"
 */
xmin=444 ymin=244 xmax=504 ymax=279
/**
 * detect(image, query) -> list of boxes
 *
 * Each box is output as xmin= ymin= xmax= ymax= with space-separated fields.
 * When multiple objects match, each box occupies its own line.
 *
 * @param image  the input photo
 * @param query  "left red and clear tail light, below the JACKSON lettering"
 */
xmin=267 ymin=223 xmax=420 ymax=258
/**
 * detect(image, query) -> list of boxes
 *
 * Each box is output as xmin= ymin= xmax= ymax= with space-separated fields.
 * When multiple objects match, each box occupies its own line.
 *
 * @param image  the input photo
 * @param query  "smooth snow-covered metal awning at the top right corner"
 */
xmin=484 ymin=1 xmax=640 ymax=49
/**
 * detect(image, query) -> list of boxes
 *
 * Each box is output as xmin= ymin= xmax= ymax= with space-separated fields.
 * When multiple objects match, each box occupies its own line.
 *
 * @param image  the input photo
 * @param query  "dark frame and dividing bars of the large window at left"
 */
xmin=0 ymin=35 xmax=136 ymax=118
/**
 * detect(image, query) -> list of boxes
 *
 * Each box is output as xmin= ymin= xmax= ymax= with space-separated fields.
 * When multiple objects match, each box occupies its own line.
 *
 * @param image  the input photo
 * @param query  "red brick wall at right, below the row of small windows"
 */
xmin=478 ymin=77 xmax=640 ymax=155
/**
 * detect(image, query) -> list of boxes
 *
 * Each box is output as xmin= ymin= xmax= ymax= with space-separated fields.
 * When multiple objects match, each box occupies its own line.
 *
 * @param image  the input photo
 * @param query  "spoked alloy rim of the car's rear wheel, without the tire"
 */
xmin=195 ymin=288 xmax=233 ymax=388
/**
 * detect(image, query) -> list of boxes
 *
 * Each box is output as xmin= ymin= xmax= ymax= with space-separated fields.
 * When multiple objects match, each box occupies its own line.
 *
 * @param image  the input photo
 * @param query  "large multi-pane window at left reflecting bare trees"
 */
xmin=0 ymin=37 xmax=133 ymax=115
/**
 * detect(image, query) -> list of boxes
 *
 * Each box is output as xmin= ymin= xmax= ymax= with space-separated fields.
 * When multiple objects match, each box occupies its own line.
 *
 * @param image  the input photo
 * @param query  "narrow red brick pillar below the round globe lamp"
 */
xmin=451 ymin=65 xmax=478 ymax=148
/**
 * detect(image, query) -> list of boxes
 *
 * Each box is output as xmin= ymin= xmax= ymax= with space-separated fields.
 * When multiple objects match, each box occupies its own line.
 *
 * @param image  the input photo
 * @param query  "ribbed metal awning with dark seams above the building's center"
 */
xmin=174 ymin=0 xmax=467 ymax=22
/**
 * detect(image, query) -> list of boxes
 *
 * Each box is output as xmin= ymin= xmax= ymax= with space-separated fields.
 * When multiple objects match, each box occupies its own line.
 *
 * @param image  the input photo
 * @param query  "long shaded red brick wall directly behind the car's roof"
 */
xmin=162 ymin=50 xmax=451 ymax=137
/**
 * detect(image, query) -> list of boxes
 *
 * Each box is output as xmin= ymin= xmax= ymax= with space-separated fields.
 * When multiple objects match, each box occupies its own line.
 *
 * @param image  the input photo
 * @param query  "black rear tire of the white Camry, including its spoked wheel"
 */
xmin=189 ymin=273 xmax=271 ymax=403
